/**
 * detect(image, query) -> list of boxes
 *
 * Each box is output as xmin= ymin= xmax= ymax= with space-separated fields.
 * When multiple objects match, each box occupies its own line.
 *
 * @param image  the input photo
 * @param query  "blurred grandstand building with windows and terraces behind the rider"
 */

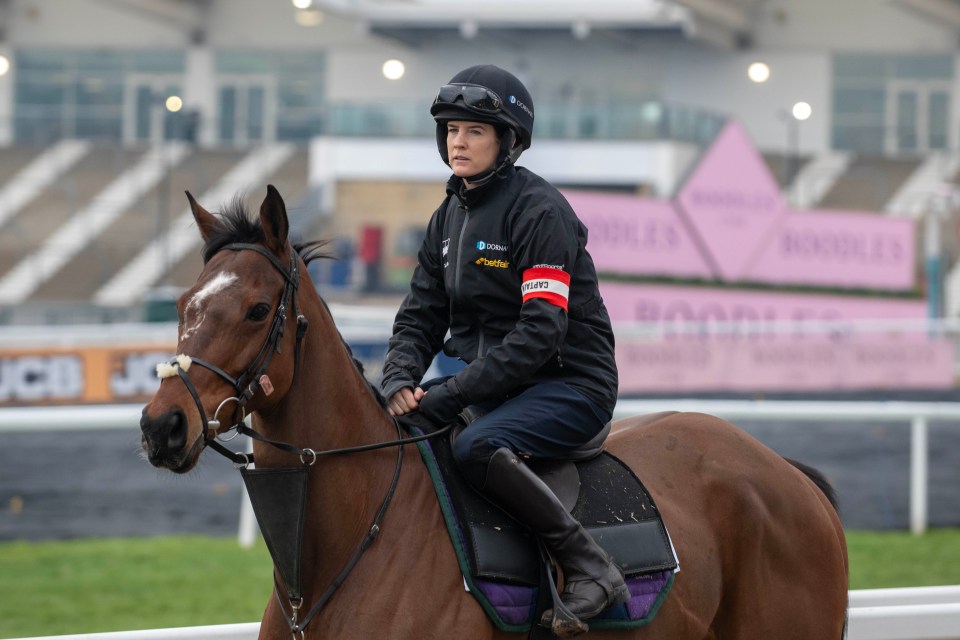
xmin=0 ymin=0 xmax=960 ymax=323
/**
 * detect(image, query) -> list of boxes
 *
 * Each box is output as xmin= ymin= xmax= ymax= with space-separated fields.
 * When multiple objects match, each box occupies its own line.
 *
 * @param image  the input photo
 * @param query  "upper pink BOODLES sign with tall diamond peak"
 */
xmin=564 ymin=121 xmax=916 ymax=291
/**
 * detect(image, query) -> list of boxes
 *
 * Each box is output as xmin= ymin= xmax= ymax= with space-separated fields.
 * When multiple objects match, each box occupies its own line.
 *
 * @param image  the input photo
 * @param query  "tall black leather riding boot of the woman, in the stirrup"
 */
xmin=481 ymin=448 xmax=630 ymax=637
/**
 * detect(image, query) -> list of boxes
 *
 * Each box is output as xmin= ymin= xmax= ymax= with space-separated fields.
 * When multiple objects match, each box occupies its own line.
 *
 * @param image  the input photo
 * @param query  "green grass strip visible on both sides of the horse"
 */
xmin=0 ymin=529 xmax=960 ymax=638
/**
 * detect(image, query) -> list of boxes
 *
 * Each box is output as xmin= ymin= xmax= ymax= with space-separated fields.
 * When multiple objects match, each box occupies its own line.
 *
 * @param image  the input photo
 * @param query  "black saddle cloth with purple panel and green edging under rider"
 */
xmin=401 ymin=414 xmax=678 ymax=632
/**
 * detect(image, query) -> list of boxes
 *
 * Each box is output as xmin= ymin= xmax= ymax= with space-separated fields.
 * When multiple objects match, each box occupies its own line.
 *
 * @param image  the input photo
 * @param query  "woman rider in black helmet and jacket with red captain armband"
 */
xmin=381 ymin=65 xmax=629 ymax=633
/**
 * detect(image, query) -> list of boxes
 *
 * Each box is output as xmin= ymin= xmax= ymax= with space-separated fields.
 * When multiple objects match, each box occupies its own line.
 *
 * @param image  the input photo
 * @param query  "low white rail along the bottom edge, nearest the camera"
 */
xmin=5 ymin=586 xmax=960 ymax=640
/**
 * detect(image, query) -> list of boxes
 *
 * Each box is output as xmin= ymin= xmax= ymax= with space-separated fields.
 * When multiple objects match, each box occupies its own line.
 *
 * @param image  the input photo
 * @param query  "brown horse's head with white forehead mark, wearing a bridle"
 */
xmin=140 ymin=186 xmax=306 ymax=473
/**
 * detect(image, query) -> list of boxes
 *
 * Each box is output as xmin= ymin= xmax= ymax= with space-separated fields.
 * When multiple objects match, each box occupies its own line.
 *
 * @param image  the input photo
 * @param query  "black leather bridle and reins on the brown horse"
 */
xmin=160 ymin=243 xmax=450 ymax=639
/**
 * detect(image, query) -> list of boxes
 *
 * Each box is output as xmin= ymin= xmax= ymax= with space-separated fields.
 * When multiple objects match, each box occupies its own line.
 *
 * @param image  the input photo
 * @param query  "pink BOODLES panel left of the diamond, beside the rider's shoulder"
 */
xmin=563 ymin=191 xmax=713 ymax=278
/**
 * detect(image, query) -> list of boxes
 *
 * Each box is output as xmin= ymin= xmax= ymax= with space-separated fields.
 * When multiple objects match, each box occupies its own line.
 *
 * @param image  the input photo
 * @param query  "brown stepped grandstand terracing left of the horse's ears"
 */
xmin=0 ymin=146 xmax=312 ymax=318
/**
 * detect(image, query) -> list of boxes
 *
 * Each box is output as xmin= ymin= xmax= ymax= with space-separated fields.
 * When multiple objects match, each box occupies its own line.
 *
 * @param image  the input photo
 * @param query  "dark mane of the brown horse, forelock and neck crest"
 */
xmin=201 ymin=194 xmax=387 ymax=409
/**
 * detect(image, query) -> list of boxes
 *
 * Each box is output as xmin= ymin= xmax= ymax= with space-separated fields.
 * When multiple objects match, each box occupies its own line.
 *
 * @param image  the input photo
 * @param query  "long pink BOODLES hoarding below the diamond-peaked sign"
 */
xmin=601 ymin=282 xmax=954 ymax=394
